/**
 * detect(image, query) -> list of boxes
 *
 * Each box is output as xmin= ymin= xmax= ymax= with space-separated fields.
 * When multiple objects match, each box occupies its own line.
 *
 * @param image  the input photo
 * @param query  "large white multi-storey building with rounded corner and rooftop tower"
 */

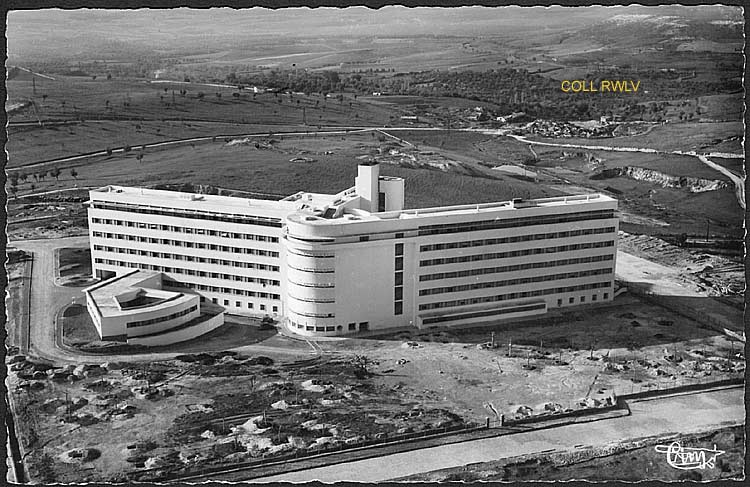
xmin=89 ymin=165 xmax=618 ymax=342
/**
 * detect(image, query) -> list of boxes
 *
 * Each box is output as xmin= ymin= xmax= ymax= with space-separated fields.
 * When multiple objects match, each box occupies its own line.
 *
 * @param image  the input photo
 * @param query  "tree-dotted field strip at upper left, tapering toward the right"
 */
xmin=7 ymin=76 xmax=406 ymax=125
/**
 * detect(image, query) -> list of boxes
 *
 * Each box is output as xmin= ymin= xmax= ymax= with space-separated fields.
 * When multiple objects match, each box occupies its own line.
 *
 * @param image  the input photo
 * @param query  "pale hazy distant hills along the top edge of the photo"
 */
xmin=6 ymin=6 xmax=742 ymax=64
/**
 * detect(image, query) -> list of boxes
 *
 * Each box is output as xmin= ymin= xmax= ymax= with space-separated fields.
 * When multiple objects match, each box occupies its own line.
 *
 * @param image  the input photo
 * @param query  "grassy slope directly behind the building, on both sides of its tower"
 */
xmin=4 ymin=134 xmax=556 ymax=208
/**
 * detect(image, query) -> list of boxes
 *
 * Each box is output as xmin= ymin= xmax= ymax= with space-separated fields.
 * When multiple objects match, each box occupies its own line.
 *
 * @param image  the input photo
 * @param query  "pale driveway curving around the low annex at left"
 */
xmin=9 ymin=236 xmax=318 ymax=364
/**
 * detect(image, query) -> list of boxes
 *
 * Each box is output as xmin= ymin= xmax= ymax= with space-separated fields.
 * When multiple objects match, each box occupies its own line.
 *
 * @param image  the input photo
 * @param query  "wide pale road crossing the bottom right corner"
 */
xmin=250 ymin=388 xmax=745 ymax=483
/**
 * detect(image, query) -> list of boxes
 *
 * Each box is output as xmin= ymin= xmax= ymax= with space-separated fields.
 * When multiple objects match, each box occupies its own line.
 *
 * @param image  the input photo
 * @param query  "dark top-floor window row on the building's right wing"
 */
xmin=419 ymin=210 xmax=615 ymax=236
